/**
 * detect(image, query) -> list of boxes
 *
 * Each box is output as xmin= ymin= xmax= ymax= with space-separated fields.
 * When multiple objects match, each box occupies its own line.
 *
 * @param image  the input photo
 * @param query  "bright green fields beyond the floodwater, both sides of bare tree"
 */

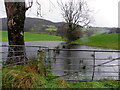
xmin=0 ymin=31 xmax=120 ymax=49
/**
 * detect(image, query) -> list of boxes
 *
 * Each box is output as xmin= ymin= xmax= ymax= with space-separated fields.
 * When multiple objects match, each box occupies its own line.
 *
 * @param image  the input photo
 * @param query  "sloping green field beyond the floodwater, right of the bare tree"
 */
xmin=75 ymin=33 xmax=120 ymax=49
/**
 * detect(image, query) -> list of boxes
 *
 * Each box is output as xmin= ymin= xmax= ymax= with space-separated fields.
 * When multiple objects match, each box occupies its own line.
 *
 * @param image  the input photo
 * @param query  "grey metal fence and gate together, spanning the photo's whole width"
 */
xmin=0 ymin=45 xmax=120 ymax=81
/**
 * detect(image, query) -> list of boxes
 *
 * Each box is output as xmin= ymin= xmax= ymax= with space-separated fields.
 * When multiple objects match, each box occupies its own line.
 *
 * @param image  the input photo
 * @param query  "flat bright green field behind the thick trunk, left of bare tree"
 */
xmin=0 ymin=31 xmax=62 ymax=42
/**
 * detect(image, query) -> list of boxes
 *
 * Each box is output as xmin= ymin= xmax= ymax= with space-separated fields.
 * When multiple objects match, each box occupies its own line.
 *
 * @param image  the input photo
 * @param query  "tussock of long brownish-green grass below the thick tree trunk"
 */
xmin=2 ymin=64 xmax=44 ymax=88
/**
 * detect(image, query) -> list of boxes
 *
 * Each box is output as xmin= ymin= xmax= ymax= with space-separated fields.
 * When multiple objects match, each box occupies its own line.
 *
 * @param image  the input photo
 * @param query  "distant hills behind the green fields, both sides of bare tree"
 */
xmin=0 ymin=17 xmax=120 ymax=37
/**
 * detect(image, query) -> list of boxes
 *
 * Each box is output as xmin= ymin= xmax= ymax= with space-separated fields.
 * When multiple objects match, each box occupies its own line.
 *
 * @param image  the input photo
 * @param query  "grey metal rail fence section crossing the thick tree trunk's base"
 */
xmin=0 ymin=45 xmax=48 ymax=66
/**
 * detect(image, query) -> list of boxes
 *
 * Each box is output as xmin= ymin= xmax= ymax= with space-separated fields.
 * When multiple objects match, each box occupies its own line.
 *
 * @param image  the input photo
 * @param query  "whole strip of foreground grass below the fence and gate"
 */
xmin=2 ymin=64 xmax=119 ymax=88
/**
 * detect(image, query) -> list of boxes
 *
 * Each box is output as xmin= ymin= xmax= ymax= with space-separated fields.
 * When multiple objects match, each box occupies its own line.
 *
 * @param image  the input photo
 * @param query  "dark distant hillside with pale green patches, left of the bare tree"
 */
xmin=0 ymin=17 xmax=64 ymax=35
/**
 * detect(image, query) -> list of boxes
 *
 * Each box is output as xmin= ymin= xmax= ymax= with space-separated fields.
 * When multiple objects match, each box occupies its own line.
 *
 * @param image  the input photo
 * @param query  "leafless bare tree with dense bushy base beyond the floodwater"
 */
xmin=58 ymin=0 xmax=90 ymax=41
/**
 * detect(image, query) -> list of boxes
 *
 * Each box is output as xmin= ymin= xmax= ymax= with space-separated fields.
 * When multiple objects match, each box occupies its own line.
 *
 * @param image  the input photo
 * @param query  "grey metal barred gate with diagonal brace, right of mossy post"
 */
xmin=46 ymin=49 xmax=120 ymax=81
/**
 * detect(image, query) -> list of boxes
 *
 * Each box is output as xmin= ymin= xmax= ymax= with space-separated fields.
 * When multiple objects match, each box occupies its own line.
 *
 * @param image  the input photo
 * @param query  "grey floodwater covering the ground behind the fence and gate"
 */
xmin=2 ymin=41 xmax=119 ymax=80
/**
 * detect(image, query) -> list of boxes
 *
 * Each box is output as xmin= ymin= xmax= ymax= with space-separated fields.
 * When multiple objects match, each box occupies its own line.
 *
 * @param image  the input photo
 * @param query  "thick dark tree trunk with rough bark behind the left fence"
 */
xmin=5 ymin=0 xmax=26 ymax=63
